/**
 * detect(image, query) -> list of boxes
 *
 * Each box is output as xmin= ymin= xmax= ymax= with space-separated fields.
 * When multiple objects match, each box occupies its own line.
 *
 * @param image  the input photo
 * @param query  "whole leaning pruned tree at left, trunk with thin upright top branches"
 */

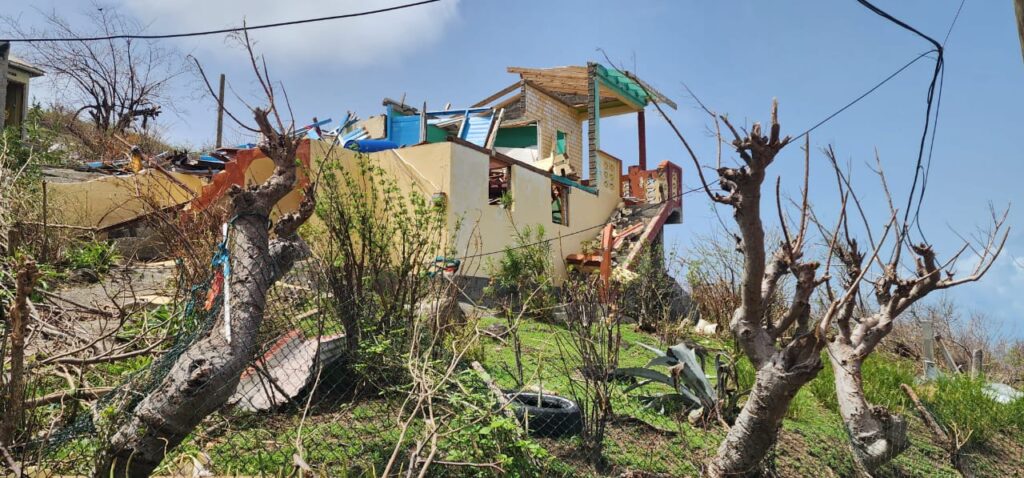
xmin=95 ymin=34 xmax=314 ymax=477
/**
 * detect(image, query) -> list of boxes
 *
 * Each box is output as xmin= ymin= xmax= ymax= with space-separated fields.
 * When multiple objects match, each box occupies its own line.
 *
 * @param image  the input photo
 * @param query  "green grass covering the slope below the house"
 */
xmin=37 ymin=317 xmax=1024 ymax=477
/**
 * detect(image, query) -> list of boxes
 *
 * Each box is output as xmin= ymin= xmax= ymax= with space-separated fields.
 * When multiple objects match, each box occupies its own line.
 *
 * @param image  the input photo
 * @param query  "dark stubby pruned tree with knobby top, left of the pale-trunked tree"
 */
xmin=708 ymin=101 xmax=824 ymax=477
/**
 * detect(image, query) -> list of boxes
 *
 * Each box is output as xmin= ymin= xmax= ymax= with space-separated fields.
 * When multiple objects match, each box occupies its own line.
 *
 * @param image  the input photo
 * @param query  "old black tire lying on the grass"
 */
xmin=506 ymin=392 xmax=583 ymax=438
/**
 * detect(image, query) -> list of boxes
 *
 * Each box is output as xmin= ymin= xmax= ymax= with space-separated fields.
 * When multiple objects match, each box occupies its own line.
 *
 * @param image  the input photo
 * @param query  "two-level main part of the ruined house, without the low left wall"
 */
xmin=321 ymin=63 xmax=682 ymax=284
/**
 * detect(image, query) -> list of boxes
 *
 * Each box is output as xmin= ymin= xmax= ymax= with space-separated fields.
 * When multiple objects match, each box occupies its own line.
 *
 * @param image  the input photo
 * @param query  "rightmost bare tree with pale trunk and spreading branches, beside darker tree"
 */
xmin=820 ymin=147 xmax=1010 ymax=472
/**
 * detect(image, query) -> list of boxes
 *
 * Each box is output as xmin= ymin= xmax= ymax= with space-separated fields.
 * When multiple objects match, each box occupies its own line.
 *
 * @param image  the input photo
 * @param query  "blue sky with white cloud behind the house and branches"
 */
xmin=0 ymin=0 xmax=1024 ymax=337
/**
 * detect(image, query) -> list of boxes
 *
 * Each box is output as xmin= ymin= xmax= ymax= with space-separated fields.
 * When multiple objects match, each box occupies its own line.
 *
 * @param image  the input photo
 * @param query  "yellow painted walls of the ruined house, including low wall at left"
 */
xmin=48 ymin=141 xmax=620 ymax=283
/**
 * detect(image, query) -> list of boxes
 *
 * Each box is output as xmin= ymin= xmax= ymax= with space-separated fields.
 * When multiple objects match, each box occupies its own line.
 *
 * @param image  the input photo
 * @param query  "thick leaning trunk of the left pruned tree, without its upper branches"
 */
xmin=95 ymin=213 xmax=307 ymax=478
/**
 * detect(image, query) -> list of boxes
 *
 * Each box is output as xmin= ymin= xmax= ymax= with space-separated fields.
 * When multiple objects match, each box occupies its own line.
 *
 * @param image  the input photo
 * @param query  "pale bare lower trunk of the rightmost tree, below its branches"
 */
xmin=828 ymin=341 xmax=910 ymax=474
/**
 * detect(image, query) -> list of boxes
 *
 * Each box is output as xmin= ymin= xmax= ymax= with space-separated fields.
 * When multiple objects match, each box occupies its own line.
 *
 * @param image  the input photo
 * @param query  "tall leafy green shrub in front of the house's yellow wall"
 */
xmin=311 ymin=155 xmax=450 ymax=389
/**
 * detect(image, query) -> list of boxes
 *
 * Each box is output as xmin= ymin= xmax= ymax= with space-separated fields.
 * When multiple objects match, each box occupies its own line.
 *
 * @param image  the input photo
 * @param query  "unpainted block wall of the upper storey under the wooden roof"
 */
xmin=523 ymin=85 xmax=587 ymax=177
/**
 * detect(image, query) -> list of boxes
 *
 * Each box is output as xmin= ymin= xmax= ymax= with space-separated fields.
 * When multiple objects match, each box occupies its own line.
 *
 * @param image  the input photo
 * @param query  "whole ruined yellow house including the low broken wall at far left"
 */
xmin=39 ymin=62 xmax=682 ymax=290
